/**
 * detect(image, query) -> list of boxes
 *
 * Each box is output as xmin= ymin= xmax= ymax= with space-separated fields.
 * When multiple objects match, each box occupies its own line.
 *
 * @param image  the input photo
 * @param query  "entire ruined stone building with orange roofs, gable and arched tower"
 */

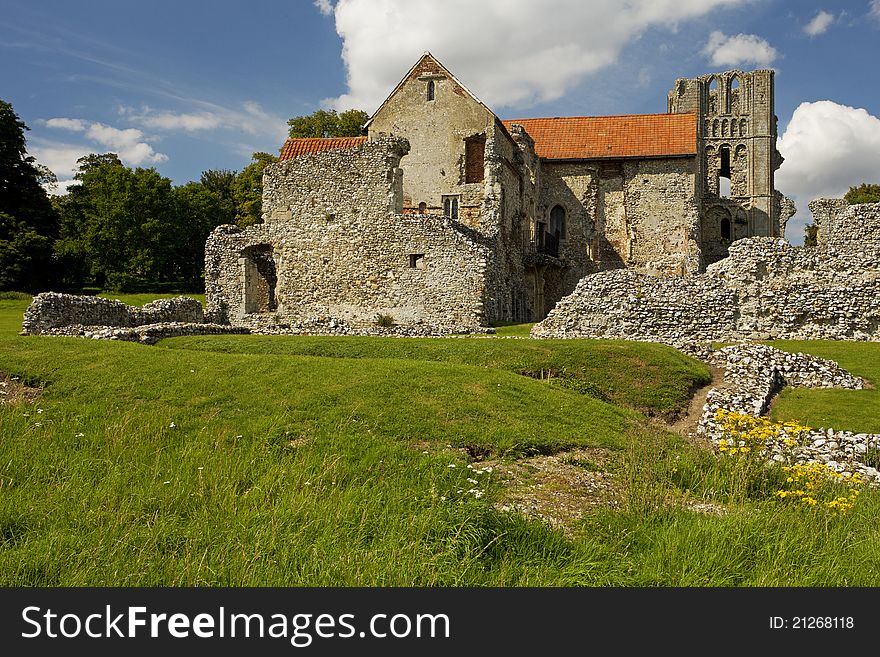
xmin=205 ymin=53 xmax=794 ymax=331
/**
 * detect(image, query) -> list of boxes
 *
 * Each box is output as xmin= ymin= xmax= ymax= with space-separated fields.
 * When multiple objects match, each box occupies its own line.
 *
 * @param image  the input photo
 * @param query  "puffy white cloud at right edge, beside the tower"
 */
xmin=776 ymin=100 xmax=880 ymax=236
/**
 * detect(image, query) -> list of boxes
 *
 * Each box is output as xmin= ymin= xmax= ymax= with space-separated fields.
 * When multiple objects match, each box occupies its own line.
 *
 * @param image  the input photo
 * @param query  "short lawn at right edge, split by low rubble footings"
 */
xmin=768 ymin=340 xmax=880 ymax=433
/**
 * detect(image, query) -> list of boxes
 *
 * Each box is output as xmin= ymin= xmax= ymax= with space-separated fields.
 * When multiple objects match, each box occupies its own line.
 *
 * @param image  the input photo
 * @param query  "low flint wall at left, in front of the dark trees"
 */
xmin=22 ymin=292 xmax=205 ymax=335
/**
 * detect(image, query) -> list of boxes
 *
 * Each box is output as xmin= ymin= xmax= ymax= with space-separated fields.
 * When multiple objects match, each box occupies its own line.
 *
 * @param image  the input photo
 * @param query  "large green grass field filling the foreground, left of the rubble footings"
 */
xmin=0 ymin=295 xmax=880 ymax=586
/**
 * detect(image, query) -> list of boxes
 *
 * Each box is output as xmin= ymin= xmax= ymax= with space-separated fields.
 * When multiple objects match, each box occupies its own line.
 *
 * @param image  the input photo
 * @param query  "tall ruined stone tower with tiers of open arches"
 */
xmin=668 ymin=70 xmax=783 ymax=264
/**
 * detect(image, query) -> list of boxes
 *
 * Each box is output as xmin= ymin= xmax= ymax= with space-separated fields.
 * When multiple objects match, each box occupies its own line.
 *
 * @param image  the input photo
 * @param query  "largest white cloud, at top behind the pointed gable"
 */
xmin=315 ymin=0 xmax=748 ymax=112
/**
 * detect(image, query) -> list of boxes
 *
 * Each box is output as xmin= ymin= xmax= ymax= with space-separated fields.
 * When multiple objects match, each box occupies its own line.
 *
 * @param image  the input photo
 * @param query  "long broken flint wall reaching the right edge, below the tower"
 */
xmin=532 ymin=204 xmax=880 ymax=344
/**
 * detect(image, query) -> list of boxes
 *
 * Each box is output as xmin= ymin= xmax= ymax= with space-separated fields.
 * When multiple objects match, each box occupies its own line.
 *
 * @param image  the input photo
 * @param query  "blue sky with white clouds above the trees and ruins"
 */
xmin=0 ymin=0 xmax=880 ymax=243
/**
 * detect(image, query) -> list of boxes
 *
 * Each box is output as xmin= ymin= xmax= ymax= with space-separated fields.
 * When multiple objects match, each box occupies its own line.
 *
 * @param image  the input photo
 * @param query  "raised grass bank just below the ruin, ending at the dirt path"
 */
xmin=161 ymin=336 xmax=710 ymax=416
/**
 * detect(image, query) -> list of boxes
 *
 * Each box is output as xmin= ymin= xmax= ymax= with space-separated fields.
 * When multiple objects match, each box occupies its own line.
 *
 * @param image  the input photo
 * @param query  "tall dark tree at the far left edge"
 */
xmin=0 ymin=100 xmax=58 ymax=292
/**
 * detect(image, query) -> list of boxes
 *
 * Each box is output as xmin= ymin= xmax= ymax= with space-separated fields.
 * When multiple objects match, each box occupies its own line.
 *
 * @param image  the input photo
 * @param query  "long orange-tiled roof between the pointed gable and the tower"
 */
xmin=502 ymin=114 xmax=697 ymax=160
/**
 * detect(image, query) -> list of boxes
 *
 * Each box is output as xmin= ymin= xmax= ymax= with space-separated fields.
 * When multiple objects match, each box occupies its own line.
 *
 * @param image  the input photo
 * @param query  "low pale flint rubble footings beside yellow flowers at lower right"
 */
xmin=697 ymin=345 xmax=880 ymax=486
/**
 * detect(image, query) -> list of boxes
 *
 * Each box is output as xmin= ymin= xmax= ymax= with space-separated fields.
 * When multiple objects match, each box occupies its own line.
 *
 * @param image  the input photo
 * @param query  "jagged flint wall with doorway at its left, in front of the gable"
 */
xmin=205 ymin=138 xmax=488 ymax=330
